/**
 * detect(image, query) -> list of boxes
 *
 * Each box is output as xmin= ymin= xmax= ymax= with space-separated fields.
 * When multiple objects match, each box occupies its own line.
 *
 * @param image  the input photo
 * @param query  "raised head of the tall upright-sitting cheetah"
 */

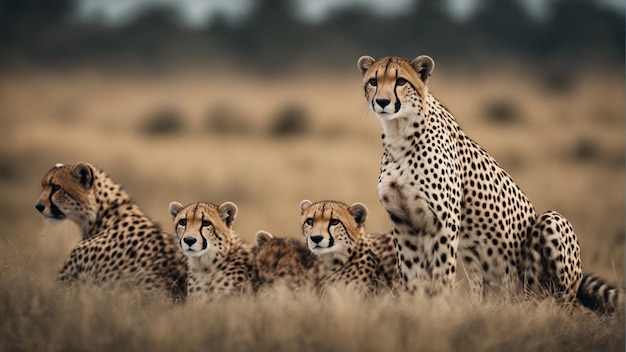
xmin=357 ymin=55 xmax=435 ymax=121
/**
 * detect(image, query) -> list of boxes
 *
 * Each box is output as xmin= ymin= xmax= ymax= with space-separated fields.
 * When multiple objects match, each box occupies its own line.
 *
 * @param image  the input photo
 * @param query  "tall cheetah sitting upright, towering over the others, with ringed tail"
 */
xmin=357 ymin=55 xmax=619 ymax=310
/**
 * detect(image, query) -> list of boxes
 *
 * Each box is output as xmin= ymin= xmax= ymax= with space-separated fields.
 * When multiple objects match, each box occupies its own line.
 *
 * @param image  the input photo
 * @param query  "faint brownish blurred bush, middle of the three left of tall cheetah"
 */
xmin=204 ymin=104 xmax=251 ymax=135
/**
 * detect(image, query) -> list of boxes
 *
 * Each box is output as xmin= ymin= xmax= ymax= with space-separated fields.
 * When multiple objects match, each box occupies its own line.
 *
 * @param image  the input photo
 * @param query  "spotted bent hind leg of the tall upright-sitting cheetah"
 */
xmin=520 ymin=211 xmax=583 ymax=304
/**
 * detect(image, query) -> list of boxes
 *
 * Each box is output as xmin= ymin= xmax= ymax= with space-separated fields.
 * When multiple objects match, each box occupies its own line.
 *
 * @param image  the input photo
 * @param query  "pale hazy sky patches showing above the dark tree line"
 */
xmin=77 ymin=0 xmax=624 ymax=26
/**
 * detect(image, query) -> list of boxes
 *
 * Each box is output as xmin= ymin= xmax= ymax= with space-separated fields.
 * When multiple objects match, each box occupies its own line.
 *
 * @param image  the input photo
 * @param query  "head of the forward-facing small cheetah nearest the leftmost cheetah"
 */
xmin=169 ymin=202 xmax=237 ymax=257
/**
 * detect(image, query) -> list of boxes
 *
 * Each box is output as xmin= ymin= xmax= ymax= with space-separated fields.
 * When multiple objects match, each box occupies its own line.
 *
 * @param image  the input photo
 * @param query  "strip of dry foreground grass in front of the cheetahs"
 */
xmin=0 ymin=268 xmax=624 ymax=352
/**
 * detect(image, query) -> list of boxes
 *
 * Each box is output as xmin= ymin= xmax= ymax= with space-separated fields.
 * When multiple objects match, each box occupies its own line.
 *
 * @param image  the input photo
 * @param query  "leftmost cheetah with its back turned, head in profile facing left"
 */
xmin=35 ymin=163 xmax=187 ymax=298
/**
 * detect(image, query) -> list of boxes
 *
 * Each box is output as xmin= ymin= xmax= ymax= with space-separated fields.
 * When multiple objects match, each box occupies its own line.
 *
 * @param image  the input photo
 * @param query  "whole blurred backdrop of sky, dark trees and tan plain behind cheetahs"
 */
xmin=0 ymin=0 xmax=625 ymax=282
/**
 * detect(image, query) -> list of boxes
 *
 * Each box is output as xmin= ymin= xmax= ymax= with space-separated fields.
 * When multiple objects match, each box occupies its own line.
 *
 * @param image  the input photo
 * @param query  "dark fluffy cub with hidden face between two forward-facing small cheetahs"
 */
xmin=254 ymin=231 xmax=318 ymax=290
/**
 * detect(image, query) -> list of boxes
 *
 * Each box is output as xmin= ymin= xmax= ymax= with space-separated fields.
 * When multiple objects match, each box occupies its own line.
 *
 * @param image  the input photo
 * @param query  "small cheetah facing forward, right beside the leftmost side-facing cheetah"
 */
xmin=169 ymin=202 xmax=256 ymax=299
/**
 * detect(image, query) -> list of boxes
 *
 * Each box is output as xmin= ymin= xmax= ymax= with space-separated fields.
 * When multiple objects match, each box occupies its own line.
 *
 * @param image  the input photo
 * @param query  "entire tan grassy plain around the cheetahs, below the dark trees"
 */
xmin=0 ymin=64 xmax=625 ymax=351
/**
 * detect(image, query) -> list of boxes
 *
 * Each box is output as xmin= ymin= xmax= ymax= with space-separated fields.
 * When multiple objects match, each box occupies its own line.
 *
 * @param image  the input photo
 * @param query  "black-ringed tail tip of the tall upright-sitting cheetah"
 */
xmin=576 ymin=274 xmax=620 ymax=314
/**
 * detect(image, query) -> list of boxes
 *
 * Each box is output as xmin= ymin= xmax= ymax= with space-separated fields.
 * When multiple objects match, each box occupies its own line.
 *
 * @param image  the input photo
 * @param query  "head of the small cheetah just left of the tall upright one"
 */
xmin=300 ymin=200 xmax=367 ymax=258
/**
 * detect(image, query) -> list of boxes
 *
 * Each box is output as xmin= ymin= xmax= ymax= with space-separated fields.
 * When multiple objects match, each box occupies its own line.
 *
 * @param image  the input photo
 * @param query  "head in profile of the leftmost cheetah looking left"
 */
xmin=35 ymin=163 xmax=98 ymax=228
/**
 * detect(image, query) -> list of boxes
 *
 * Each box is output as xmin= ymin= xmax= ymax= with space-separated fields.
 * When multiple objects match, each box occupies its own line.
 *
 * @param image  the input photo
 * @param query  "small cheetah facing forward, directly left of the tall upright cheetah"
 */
xmin=300 ymin=200 xmax=399 ymax=294
